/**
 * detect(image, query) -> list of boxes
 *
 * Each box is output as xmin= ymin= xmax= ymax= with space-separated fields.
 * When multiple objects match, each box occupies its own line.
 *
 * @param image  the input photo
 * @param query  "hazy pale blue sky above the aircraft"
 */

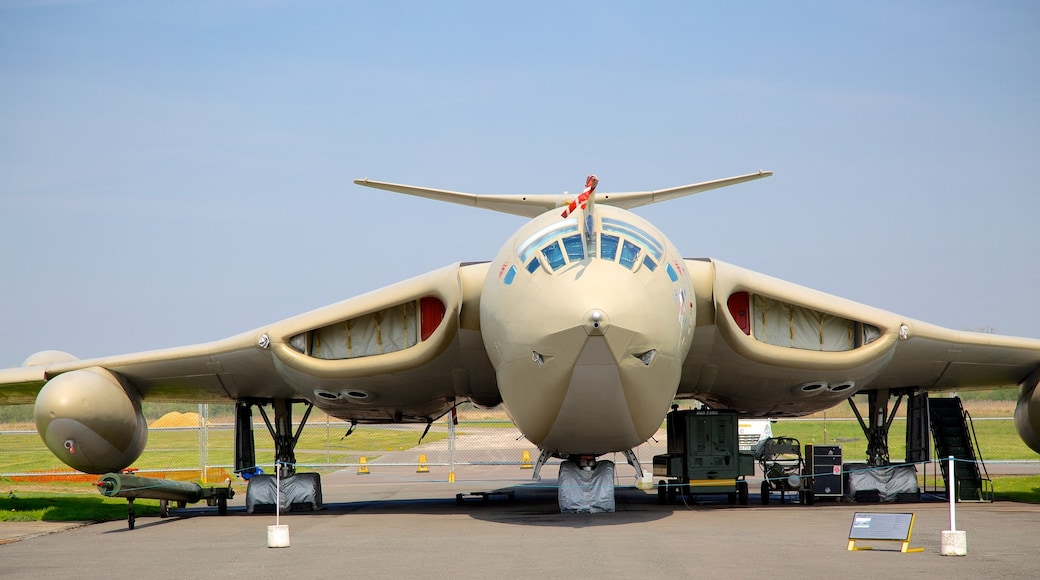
xmin=0 ymin=0 xmax=1040 ymax=367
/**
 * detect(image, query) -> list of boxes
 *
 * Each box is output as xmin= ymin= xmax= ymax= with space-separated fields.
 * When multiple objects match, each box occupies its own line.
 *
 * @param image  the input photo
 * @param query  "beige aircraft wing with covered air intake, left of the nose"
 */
xmin=0 ymin=264 xmax=497 ymax=423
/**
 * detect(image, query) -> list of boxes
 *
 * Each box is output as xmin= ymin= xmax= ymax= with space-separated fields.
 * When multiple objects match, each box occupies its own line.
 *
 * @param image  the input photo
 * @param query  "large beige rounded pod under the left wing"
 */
xmin=34 ymin=367 xmax=148 ymax=474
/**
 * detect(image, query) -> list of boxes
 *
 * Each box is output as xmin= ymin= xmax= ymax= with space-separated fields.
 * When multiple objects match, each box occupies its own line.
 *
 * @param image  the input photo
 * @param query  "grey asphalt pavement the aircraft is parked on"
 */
xmin=0 ymin=466 xmax=1040 ymax=580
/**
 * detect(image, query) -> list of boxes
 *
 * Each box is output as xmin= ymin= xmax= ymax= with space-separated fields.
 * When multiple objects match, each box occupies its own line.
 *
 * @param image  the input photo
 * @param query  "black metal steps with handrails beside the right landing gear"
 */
xmin=928 ymin=397 xmax=993 ymax=501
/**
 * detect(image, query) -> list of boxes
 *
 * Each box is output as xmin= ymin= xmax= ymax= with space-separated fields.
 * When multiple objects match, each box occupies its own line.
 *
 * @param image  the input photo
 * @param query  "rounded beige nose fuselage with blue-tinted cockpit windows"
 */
xmin=480 ymin=207 xmax=696 ymax=455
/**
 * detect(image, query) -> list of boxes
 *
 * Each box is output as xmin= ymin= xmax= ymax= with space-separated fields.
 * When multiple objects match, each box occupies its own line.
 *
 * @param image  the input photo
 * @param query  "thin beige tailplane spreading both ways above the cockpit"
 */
xmin=354 ymin=172 xmax=773 ymax=217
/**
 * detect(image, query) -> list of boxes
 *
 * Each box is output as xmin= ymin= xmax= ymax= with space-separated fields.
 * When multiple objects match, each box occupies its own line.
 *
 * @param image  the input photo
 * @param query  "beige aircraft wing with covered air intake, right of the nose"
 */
xmin=679 ymin=260 xmax=1040 ymax=417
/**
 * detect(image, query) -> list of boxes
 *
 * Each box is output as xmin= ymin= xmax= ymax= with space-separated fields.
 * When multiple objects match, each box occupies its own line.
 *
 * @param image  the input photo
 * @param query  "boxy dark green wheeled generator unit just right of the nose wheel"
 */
xmin=653 ymin=406 xmax=755 ymax=505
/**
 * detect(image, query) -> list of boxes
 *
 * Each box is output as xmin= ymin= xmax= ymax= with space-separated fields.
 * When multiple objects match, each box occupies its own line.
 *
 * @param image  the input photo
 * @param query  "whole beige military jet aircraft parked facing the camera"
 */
xmin=0 ymin=172 xmax=1040 ymax=509
